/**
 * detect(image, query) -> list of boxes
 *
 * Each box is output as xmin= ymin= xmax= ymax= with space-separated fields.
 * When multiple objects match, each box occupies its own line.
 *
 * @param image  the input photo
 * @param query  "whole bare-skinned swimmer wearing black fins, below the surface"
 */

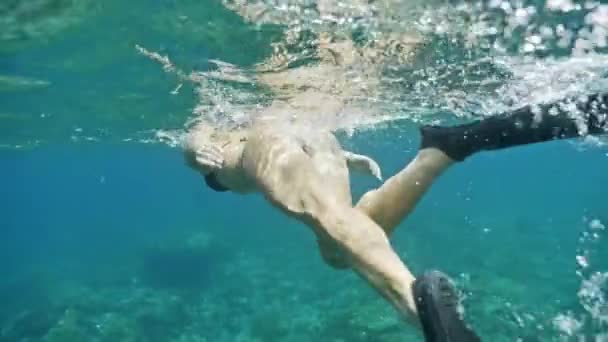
xmin=184 ymin=93 xmax=608 ymax=342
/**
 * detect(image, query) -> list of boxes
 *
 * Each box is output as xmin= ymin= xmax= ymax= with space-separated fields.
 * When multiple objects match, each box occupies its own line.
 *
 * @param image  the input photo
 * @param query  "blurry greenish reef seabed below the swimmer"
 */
xmin=0 ymin=218 xmax=605 ymax=342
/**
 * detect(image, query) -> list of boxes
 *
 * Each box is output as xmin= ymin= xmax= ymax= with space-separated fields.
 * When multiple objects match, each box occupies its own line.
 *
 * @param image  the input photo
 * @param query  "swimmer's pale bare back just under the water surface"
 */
xmin=243 ymin=124 xmax=352 ymax=214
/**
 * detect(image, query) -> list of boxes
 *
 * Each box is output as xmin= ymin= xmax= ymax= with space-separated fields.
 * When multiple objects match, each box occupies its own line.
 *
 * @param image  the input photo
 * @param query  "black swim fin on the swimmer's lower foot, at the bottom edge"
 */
xmin=412 ymin=271 xmax=481 ymax=342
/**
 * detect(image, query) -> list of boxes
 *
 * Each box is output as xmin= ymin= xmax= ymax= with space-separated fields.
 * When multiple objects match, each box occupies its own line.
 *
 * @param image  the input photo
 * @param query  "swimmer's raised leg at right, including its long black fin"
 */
xmin=357 ymin=94 xmax=608 ymax=235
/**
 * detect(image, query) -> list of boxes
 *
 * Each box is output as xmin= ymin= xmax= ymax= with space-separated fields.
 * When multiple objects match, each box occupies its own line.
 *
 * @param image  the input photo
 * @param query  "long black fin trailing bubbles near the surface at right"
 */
xmin=421 ymin=94 xmax=608 ymax=161
